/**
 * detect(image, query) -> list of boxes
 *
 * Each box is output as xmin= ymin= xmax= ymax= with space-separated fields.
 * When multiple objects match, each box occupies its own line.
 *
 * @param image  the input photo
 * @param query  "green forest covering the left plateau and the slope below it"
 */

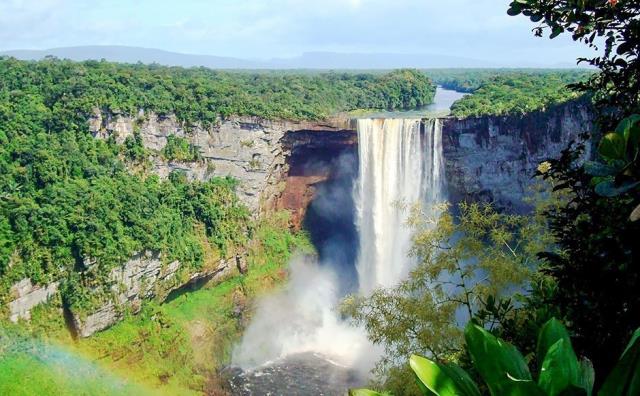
xmin=0 ymin=59 xmax=434 ymax=308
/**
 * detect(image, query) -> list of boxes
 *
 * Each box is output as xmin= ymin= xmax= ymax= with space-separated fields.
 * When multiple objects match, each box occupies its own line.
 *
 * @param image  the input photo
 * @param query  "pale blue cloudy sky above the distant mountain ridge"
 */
xmin=0 ymin=0 xmax=586 ymax=65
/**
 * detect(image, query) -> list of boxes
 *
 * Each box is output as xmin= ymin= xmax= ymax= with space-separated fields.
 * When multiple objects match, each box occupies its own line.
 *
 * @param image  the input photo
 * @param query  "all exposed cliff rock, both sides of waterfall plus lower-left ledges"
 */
xmin=3 ymin=103 xmax=593 ymax=337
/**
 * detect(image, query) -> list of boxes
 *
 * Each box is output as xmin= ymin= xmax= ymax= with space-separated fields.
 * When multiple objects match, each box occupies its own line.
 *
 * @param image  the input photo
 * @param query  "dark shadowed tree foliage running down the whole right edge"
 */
xmin=509 ymin=0 xmax=640 ymax=381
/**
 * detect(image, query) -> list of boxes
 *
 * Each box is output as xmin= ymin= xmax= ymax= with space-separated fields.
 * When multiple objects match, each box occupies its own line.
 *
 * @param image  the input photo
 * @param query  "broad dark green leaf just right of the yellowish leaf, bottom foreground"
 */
xmin=464 ymin=322 xmax=531 ymax=396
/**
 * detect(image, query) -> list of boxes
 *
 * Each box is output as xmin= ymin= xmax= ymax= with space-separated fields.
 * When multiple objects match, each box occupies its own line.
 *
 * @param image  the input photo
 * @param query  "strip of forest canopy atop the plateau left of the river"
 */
xmin=0 ymin=58 xmax=435 ymax=124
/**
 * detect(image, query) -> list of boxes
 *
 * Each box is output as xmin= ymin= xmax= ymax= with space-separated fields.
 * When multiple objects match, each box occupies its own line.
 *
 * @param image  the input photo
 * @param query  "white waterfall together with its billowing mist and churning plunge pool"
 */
xmin=232 ymin=118 xmax=445 ymax=395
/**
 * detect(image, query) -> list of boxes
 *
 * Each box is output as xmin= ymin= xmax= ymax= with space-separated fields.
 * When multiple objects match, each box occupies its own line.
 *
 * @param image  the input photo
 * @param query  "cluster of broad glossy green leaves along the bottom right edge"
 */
xmin=350 ymin=319 xmax=640 ymax=396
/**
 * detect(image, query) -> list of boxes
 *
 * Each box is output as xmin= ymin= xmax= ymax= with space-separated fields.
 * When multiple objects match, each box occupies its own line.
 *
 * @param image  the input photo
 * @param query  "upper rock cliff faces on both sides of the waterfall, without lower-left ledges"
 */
xmin=90 ymin=102 xmax=594 ymax=220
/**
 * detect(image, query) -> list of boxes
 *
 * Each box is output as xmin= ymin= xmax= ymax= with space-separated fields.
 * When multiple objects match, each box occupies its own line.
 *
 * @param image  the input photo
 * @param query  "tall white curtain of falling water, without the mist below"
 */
xmin=354 ymin=119 xmax=444 ymax=294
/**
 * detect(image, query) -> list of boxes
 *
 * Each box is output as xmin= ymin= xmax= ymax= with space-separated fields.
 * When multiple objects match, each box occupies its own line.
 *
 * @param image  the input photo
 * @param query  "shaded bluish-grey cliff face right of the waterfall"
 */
xmin=442 ymin=103 xmax=594 ymax=212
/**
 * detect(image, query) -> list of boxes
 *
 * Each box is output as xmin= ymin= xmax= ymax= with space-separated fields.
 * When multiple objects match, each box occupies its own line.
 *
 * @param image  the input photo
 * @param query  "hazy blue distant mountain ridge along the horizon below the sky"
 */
xmin=0 ymin=45 xmax=575 ymax=69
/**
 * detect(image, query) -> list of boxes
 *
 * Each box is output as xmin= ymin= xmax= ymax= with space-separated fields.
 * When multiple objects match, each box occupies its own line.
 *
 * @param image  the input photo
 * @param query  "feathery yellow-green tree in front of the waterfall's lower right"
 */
xmin=344 ymin=203 xmax=549 ymax=395
